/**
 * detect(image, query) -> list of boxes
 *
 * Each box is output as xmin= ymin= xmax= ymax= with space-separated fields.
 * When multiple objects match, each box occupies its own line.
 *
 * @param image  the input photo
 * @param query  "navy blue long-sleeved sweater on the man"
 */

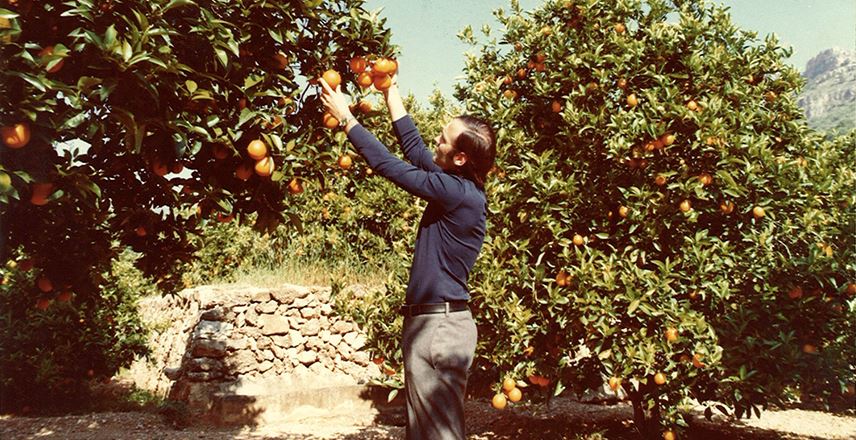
xmin=348 ymin=116 xmax=487 ymax=304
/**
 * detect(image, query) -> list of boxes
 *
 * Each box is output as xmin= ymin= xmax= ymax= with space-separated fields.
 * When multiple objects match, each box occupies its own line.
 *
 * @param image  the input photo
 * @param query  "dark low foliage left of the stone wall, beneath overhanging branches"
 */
xmin=0 ymin=253 xmax=151 ymax=412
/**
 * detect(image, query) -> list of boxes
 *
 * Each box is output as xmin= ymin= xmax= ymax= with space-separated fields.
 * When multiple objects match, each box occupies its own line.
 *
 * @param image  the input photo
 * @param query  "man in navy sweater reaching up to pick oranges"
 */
xmin=320 ymin=70 xmax=496 ymax=440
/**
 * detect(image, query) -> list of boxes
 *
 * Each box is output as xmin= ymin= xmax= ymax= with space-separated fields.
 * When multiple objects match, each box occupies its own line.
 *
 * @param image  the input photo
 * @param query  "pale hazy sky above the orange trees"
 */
xmin=365 ymin=0 xmax=856 ymax=101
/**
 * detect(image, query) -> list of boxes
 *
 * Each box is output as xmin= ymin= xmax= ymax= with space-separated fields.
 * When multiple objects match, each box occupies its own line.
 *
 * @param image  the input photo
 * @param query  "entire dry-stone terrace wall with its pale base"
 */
xmin=129 ymin=285 xmax=380 ymax=422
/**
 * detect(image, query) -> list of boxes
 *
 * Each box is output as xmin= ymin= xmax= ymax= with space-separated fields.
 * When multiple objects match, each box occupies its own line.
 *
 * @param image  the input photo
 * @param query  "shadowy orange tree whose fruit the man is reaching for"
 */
xmin=0 ymin=0 xmax=393 ymax=410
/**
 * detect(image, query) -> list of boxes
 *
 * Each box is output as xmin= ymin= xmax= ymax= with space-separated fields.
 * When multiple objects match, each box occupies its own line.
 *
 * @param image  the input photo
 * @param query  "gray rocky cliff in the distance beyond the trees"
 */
xmin=797 ymin=49 xmax=856 ymax=131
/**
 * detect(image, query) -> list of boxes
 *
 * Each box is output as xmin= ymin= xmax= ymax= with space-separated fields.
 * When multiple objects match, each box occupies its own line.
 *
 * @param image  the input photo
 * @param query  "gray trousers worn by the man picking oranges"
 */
xmin=402 ymin=310 xmax=477 ymax=440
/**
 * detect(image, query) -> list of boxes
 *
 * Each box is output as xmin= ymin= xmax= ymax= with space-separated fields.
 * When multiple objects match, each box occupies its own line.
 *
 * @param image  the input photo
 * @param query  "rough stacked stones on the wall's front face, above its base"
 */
xmin=185 ymin=286 xmax=377 ymax=383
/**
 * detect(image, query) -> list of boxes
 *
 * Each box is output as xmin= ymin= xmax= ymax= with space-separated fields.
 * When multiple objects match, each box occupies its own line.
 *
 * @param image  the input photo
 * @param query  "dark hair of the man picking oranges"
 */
xmin=452 ymin=115 xmax=496 ymax=189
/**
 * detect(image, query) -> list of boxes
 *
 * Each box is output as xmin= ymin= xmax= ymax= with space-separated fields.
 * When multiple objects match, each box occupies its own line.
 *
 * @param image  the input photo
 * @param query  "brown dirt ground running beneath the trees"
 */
xmin=0 ymin=398 xmax=856 ymax=440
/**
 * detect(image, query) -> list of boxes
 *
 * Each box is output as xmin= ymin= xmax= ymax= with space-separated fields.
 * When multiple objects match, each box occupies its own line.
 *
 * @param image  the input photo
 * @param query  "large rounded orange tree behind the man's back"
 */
xmin=448 ymin=0 xmax=856 ymax=437
